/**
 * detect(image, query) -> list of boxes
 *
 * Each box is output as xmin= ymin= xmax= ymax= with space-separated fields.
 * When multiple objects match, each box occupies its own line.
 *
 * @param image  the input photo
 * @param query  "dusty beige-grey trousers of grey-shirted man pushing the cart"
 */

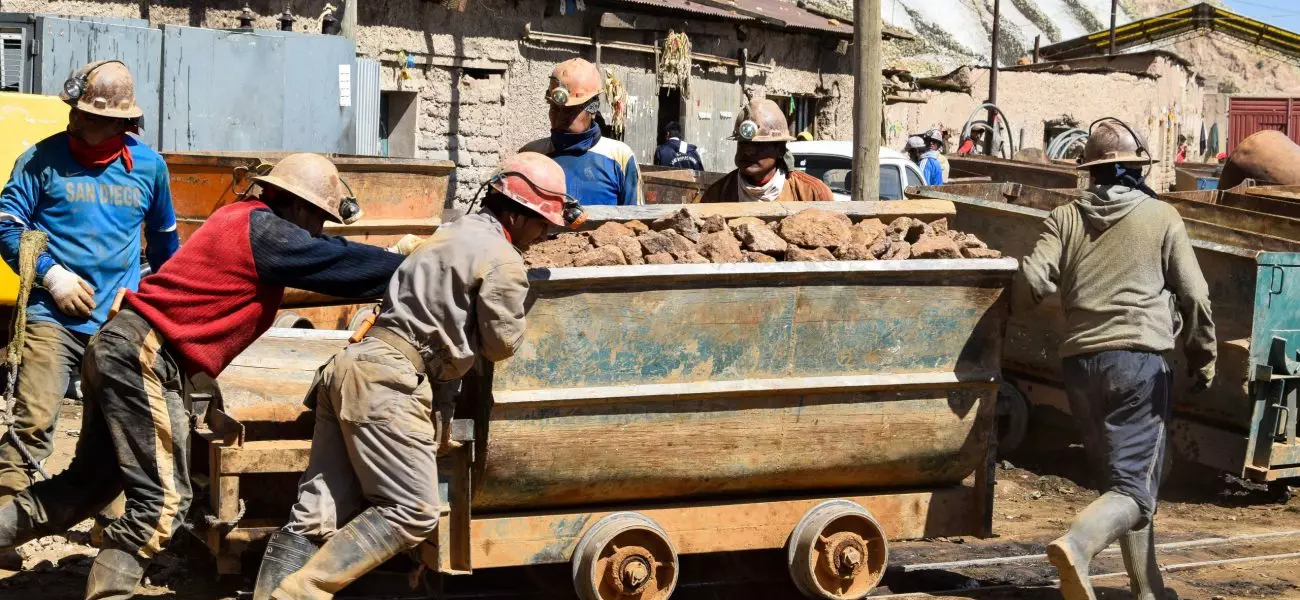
xmin=285 ymin=338 xmax=439 ymax=547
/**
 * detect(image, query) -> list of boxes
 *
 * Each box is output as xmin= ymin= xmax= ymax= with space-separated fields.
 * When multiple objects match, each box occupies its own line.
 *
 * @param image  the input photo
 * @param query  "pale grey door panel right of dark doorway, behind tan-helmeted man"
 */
xmin=681 ymin=78 xmax=744 ymax=173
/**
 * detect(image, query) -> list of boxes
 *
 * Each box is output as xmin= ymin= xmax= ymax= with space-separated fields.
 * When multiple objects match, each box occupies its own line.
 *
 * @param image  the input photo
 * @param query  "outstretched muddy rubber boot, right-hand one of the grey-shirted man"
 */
xmin=270 ymin=508 xmax=406 ymax=600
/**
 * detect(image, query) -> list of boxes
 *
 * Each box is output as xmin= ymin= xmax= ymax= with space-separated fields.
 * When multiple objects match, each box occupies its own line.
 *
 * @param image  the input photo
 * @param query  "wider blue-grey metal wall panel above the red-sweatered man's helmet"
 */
xmin=161 ymin=25 xmax=356 ymax=153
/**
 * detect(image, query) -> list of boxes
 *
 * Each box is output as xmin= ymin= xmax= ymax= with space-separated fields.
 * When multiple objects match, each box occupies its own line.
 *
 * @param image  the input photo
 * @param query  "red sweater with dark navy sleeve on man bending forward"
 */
xmin=125 ymin=200 xmax=402 ymax=377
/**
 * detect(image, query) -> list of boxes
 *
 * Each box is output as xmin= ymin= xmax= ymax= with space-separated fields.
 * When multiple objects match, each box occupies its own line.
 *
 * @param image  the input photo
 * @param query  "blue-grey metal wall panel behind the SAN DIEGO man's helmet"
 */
xmin=33 ymin=17 xmax=163 ymax=148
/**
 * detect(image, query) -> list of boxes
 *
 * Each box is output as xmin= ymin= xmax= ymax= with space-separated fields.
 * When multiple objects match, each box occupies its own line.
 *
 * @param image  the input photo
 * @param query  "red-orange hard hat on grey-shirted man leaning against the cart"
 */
xmin=488 ymin=152 xmax=586 ymax=229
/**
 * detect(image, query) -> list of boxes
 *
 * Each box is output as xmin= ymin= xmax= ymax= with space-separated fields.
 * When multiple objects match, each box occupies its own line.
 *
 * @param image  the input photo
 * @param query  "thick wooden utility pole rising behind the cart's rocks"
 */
xmin=853 ymin=0 xmax=884 ymax=201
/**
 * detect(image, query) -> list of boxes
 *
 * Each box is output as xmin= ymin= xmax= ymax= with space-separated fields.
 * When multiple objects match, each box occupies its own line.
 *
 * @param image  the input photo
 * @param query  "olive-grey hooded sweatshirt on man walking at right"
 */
xmin=1015 ymin=186 xmax=1216 ymax=379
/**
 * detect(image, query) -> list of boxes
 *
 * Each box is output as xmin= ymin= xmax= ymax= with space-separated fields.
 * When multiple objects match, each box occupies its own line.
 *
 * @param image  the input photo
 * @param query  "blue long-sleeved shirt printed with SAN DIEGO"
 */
xmin=0 ymin=132 xmax=178 ymax=334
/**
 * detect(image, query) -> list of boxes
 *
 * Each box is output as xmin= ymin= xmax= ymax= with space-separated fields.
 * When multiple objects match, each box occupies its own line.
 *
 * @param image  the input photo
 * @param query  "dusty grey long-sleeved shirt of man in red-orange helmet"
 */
xmin=374 ymin=210 xmax=528 ymax=382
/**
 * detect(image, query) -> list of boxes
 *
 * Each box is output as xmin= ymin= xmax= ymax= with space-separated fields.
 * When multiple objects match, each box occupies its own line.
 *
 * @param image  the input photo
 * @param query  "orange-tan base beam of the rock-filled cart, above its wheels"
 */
xmin=471 ymin=487 xmax=979 ymax=569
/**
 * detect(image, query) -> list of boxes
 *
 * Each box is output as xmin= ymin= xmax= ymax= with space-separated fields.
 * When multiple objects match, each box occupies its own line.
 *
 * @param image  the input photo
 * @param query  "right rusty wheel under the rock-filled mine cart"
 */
xmin=787 ymin=500 xmax=889 ymax=600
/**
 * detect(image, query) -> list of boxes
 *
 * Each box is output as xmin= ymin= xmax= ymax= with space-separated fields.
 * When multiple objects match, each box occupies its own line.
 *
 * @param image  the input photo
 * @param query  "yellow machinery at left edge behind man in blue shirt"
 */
xmin=0 ymin=92 xmax=68 ymax=306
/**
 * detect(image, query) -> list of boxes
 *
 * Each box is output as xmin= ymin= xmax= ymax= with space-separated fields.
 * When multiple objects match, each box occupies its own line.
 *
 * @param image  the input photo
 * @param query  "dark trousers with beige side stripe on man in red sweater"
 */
xmin=14 ymin=309 xmax=190 ymax=558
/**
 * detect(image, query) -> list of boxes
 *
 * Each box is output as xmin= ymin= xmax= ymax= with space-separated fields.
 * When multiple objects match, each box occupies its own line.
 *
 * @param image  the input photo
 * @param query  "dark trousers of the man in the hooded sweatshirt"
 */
xmin=1062 ymin=351 xmax=1173 ymax=526
